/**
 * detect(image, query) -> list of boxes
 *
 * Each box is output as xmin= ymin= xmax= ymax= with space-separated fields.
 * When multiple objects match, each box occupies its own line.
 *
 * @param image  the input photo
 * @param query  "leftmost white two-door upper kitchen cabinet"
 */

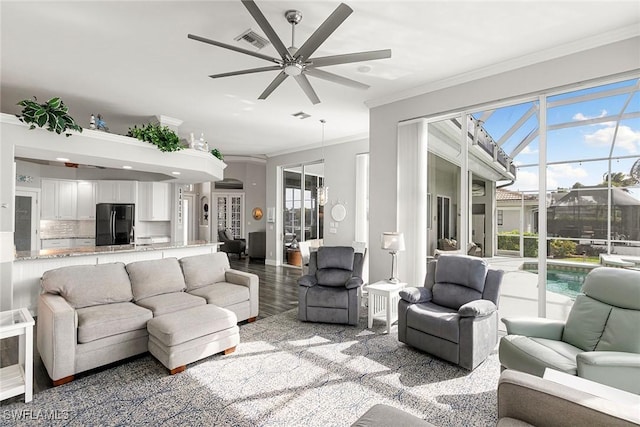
xmin=40 ymin=179 xmax=78 ymax=220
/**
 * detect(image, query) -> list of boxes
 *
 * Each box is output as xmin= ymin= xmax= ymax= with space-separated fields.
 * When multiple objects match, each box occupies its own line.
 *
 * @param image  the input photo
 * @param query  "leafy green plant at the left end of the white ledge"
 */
xmin=16 ymin=96 xmax=82 ymax=137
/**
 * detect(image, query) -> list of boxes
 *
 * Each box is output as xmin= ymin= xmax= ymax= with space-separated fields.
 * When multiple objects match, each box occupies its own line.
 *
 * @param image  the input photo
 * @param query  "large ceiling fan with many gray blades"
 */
xmin=187 ymin=0 xmax=391 ymax=104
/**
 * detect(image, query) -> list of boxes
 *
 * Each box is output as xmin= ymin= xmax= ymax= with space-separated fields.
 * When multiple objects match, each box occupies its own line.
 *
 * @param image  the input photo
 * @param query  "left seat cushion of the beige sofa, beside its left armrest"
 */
xmin=76 ymin=302 xmax=153 ymax=344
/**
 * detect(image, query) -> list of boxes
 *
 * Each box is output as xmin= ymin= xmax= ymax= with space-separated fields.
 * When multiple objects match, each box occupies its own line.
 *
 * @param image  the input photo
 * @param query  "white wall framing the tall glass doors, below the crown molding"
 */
xmin=369 ymin=37 xmax=640 ymax=282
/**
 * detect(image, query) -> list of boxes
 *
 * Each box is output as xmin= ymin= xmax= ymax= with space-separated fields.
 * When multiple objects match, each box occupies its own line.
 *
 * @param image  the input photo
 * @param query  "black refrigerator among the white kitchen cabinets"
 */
xmin=96 ymin=203 xmax=135 ymax=246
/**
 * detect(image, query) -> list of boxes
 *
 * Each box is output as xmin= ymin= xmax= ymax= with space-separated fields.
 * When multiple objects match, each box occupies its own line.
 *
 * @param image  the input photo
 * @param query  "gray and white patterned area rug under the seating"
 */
xmin=0 ymin=310 xmax=500 ymax=427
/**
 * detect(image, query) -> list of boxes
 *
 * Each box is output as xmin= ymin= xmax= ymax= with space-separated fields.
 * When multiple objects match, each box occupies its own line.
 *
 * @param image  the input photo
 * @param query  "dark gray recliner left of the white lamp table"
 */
xmin=298 ymin=246 xmax=364 ymax=325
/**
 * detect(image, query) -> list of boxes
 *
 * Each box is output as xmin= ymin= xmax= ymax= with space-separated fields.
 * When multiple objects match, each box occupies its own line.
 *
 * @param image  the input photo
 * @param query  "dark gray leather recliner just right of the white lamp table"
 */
xmin=398 ymin=254 xmax=504 ymax=370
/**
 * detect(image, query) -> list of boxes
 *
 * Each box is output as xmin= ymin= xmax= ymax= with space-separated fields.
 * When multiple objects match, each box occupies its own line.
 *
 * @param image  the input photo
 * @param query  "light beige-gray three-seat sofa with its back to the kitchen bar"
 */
xmin=37 ymin=253 xmax=258 ymax=385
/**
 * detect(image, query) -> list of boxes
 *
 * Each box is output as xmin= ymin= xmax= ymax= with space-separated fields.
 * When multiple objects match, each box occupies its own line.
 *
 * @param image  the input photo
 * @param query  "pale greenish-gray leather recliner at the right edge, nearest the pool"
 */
xmin=499 ymin=267 xmax=640 ymax=394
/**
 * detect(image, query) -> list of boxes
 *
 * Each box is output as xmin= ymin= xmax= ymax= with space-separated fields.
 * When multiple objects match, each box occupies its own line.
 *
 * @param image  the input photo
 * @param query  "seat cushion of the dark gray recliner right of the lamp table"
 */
xmin=407 ymin=302 xmax=460 ymax=343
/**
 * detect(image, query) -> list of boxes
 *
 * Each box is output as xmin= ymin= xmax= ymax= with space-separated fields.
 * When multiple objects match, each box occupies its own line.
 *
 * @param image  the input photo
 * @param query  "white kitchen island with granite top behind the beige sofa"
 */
xmin=13 ymin=241 xmax=220 ymax=313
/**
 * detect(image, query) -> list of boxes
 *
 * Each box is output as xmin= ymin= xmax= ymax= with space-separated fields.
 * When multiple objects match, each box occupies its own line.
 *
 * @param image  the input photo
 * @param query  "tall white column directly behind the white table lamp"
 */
xmin=398 ymin=119 xmax=428 ymax=286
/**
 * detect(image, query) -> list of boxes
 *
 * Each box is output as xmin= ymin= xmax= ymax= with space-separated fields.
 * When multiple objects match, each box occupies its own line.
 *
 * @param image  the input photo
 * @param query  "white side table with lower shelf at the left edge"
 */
xmin=0 ymin=308 xmax=35 ymax=403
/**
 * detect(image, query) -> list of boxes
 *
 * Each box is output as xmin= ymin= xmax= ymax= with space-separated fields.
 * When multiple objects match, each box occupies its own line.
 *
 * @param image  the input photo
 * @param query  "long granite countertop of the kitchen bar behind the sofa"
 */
xmin=15 ymin=240 xmax=220 ymax=261
